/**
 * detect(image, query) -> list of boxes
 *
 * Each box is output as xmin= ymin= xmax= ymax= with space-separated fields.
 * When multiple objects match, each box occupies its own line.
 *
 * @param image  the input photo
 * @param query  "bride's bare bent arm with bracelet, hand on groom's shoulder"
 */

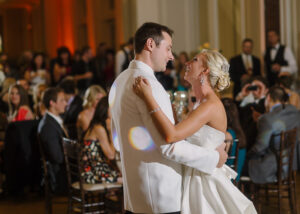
xmin=134 ymin=76 xmax=214 ymax=143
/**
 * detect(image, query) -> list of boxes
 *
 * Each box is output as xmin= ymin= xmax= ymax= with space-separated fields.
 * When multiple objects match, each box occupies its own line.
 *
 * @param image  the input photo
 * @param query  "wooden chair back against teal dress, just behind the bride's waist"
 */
xmin=224 ymin=139 xmax=239 ymax=171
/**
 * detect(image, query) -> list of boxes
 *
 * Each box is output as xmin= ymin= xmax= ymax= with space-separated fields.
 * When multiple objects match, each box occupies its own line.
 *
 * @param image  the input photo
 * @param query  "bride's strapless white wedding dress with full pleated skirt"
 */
xmin=182 ymin=125 xmax=256 ymax=214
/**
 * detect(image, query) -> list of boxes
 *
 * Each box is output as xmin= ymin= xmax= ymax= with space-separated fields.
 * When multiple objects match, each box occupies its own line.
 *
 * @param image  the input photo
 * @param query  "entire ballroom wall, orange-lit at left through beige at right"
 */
xmin=0 ymin=0 xmax=300 ymax=76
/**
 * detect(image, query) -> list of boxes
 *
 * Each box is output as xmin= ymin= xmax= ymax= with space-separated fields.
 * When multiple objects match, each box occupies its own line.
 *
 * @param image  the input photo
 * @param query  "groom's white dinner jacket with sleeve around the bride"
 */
xmin=109 ymin=60 xmax=219 ymax=213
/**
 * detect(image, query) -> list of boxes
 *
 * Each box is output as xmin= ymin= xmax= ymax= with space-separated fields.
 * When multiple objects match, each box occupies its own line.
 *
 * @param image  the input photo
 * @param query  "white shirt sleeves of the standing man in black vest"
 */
xmin=270 ymin=43 xmax=298 ymax=75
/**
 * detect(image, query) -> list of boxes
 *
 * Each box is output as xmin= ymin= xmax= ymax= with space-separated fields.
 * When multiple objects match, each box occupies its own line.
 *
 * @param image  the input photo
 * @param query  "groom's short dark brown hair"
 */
xmin=134 ymin=22 xmax=173 ymax=54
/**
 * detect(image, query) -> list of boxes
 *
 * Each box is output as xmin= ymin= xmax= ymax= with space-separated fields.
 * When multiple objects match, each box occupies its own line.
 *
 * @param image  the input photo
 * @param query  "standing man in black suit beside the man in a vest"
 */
xmin=229 ymin=38 xmax=261 ymax=97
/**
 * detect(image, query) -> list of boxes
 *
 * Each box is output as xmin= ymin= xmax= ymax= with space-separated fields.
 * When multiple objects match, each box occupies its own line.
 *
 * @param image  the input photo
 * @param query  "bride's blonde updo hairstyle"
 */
xmin=201 ymin=49 xmax=230 ymax=91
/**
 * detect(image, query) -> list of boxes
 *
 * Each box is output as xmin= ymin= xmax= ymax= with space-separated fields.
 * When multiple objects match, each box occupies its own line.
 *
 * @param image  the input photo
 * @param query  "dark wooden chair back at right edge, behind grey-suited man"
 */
xmin=276 ymin=128 xmax=297 ymax=184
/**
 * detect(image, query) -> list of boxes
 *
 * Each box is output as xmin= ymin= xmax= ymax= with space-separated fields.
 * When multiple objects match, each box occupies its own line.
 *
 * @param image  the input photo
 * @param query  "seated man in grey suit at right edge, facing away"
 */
xmin=248 ymin=86 xmax=300 ymax=184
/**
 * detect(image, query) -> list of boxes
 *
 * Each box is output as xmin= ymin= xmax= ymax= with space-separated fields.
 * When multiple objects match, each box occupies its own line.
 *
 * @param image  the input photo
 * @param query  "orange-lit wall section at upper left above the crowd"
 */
xmin=0 ymin=0 xmax=124 ymax=60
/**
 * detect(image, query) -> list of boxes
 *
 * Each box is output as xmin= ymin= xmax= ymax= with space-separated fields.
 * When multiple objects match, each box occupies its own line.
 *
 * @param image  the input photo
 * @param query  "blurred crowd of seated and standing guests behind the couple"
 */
xmin=0 ymin=31 xmax=300 ymax=198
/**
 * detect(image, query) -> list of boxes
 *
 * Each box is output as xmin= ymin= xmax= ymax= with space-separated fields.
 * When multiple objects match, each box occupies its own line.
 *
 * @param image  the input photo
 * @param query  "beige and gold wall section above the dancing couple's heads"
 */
xmin=123 ymin=0 xmax=265 ymax=57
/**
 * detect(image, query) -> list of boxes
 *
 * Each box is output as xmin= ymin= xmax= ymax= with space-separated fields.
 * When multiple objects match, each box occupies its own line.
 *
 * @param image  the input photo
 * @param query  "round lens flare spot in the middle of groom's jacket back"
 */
xmin=128 ymin=126 xmax=155 ymax=151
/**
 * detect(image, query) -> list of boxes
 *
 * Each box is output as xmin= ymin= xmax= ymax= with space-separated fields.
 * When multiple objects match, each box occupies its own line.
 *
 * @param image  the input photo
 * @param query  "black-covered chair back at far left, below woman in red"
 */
xmin=3 ymin=120 xmax=41 ymax=195
